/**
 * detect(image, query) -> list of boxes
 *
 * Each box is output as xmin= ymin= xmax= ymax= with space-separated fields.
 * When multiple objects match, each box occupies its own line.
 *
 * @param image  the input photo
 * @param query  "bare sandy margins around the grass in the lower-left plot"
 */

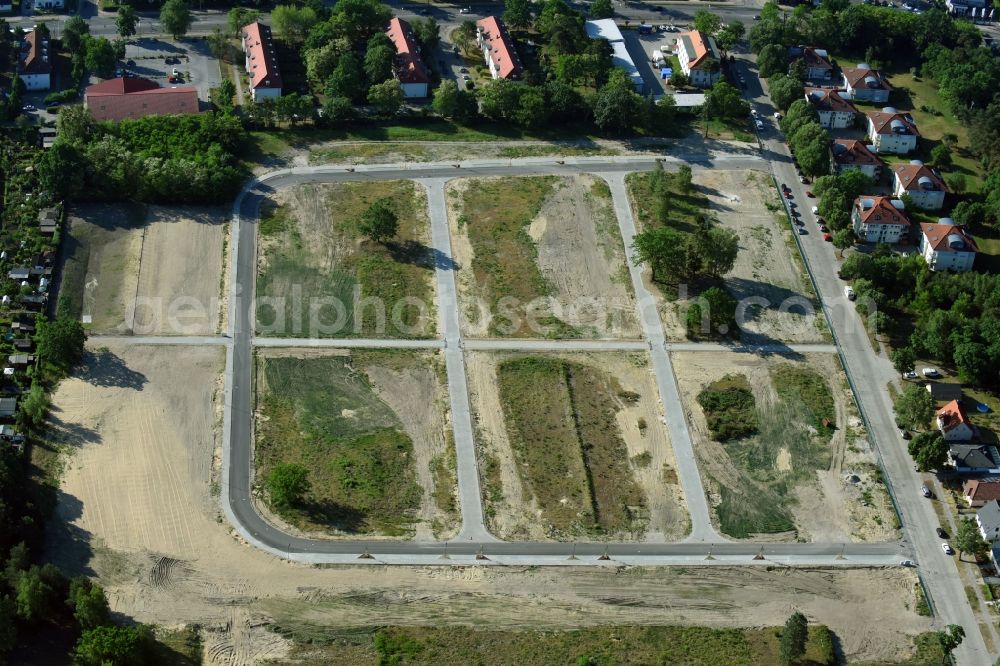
xmin=257 ymin=348 xmax=461 ymax=541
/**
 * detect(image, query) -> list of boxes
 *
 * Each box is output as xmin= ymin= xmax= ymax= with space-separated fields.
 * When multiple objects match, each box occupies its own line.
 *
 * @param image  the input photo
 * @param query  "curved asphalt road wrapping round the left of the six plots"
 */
xmin=222 ymin=156 xmax=902 ymax=566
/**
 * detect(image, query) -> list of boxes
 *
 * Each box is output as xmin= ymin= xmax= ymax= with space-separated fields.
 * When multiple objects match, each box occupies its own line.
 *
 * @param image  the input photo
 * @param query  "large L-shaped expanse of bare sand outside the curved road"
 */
xmin=48 ymin=345 xmax=929 ymax=666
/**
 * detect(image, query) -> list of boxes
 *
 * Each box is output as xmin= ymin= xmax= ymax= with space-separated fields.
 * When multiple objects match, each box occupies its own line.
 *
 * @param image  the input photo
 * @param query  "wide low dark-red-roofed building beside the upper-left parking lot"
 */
xmin=83 ymin=78 xmax=200 ymax=121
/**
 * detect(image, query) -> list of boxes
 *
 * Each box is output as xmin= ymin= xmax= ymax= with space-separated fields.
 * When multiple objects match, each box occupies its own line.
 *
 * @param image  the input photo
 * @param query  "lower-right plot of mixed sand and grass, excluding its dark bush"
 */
xmin=672 ymin=353 xmax=897 ymax=542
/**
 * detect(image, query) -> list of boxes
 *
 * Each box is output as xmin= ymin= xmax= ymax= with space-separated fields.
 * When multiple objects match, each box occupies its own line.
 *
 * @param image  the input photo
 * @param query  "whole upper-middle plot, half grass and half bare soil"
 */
xmin=447 ymin=175 xmax=639 ymax=338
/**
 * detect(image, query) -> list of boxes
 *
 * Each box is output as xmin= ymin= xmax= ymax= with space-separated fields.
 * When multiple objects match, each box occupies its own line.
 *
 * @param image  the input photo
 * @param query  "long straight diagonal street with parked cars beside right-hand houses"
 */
xmin=738 ymin=59 xmax=993 ymax=664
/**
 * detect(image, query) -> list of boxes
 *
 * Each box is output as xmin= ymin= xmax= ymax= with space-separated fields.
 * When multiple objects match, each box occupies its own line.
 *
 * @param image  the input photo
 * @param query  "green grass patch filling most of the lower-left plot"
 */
xmin=255 ymin=356 xmax=421 ymax=536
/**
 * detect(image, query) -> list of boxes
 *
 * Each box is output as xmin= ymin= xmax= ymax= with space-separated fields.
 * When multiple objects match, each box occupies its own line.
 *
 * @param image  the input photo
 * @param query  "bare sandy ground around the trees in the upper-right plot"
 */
xmin=626 ymin=169 xmax=826 ymax=344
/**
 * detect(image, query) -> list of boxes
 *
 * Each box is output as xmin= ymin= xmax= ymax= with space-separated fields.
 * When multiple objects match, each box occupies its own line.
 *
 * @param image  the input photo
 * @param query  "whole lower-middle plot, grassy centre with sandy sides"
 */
xmin=466 ymin=352 xmax=689 ymax=541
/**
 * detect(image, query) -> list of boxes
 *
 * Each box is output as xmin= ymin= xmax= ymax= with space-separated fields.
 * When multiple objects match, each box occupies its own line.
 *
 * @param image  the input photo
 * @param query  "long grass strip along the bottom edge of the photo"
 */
xmin=278 ymin=625 xmax=848 ymax=666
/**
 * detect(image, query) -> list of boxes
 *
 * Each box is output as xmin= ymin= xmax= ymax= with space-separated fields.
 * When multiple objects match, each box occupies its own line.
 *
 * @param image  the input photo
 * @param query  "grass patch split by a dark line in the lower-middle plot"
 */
xmin=497 ymin=356 xmax=645 ymax=535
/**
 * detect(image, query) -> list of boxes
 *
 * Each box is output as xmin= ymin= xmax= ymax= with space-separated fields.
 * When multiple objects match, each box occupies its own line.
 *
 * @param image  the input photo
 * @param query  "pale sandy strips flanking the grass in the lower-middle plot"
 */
xmin=466 ymin=352 xmax=690 ymax=542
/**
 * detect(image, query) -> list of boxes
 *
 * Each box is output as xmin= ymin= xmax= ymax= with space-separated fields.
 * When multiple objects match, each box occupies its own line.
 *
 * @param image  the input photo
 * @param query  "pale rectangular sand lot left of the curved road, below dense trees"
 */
xmin=133 ymin=206 xmax=229 ymax=335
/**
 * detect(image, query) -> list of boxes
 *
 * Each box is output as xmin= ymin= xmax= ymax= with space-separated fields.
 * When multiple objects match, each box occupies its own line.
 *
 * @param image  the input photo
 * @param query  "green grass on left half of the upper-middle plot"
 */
xmin=458 ymin=176 xmax=573 ymax=337
